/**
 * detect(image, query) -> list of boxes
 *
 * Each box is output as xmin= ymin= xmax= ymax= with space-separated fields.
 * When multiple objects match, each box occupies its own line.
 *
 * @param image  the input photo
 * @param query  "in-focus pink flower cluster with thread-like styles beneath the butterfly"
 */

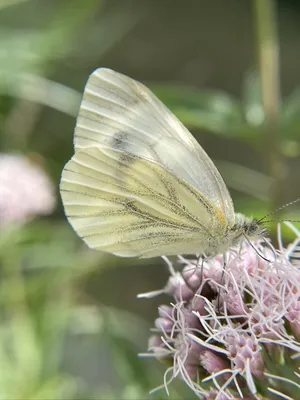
xmin=140 ymin=230 xmax=300 ymax=400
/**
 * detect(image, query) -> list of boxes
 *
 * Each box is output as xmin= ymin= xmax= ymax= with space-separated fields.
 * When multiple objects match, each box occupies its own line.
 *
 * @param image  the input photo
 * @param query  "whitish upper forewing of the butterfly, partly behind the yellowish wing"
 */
xmin=74 ymin=68 xmax=235 ymax=227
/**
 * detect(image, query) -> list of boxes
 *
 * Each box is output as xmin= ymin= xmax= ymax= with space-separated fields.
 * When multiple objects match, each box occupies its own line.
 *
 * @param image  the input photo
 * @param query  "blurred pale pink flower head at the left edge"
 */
xmin=0 ymin=153 xmax=55 ymax=227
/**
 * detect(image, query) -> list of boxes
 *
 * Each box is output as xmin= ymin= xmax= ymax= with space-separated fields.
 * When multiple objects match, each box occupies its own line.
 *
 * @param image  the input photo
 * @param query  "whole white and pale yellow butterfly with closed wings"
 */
xmin=60 ymin=68 xmax=264 ymax=258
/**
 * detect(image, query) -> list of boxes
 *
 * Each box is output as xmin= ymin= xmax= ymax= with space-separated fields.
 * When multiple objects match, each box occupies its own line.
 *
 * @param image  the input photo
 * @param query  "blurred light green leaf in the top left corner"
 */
xmin=0 ymin=0 xmax=99 ymax=94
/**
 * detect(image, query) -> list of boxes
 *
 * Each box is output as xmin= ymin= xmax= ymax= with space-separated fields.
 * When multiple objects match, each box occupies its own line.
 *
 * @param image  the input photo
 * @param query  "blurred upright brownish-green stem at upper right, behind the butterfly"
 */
xmin=254 ymin=0 xmax=286 ymax=209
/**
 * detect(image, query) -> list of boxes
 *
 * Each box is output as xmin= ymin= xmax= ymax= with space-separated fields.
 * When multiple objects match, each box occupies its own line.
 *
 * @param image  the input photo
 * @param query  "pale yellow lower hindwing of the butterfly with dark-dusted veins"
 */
xmin=60 ymin=146 xmax=226 ymax=257
